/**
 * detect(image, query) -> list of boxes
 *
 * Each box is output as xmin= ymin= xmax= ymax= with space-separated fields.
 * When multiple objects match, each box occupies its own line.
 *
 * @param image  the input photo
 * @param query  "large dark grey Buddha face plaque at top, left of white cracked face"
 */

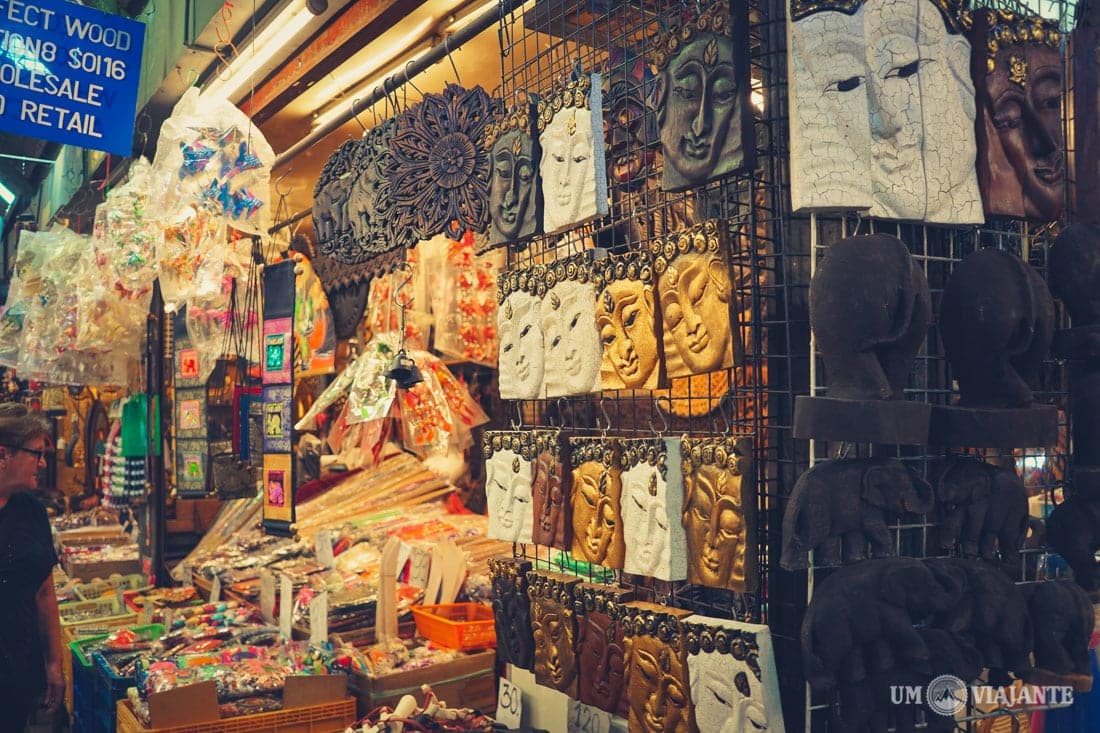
xmin=653 ymin=2 xmax=755 ymax=190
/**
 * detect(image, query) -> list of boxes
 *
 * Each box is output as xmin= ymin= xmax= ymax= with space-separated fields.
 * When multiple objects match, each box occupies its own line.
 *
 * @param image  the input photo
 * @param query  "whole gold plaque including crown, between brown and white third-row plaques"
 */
xmin=569 ymin=438 xmax=625 ymax=568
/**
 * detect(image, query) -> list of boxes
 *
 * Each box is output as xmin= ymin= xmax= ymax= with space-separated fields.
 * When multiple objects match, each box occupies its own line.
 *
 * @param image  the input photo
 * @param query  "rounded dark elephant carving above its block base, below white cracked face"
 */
xmin=810 ymin=234 xmax=932 ymax=400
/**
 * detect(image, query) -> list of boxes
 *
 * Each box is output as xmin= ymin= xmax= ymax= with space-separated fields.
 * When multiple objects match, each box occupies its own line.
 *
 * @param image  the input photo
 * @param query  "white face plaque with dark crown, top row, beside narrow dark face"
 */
xmin=538 ymin=74 xmax=607 ymax=233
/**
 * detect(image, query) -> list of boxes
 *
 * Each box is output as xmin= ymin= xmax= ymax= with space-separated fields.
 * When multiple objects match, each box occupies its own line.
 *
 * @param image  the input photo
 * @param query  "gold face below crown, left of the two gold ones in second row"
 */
xmin=596 ymin=280 xmax=660 ymax=390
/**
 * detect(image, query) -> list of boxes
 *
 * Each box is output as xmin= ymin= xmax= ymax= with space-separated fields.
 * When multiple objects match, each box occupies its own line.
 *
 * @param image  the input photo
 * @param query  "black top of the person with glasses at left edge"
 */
xmin=0 ymin=493 xmax=57 ymax=692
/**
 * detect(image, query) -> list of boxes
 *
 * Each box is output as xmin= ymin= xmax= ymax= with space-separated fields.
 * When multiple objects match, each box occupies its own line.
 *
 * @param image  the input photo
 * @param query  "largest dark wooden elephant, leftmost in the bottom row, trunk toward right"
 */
xmin=802 ymin=558 xmax=961 ymax=691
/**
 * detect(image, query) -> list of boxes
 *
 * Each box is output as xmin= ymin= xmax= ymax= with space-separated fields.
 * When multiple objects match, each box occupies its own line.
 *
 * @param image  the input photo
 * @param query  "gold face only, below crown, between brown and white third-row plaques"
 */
xmin=572 ymin=460 xmax=626 ymax=568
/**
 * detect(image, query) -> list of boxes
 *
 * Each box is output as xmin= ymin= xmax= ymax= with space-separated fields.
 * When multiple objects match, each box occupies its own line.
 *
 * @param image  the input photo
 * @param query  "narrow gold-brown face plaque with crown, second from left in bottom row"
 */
xmin=527 ymin=570 xmax=581 ymax=697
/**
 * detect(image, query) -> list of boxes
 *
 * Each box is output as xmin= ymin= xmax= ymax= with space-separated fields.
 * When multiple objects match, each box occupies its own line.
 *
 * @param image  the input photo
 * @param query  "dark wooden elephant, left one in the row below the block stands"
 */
xmin=780 ymin=458 xmax=933 ymax=570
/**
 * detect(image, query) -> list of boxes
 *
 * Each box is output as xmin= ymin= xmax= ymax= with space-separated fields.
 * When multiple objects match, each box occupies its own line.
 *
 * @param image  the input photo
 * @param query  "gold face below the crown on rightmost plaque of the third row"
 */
xmin=682 ymin=463 xmax=748 ymax=591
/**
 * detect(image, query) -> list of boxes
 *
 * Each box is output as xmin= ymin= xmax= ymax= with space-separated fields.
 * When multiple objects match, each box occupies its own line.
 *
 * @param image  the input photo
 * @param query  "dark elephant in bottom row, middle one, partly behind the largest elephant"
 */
xmin=924 ymin=558 xmax=1033 ymax=680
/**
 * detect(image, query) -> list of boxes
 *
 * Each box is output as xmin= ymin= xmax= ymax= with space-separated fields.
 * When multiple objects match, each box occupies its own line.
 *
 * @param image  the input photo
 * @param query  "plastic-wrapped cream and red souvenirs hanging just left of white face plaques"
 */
xmin=417 ymin=231 xmax=506 ymax=365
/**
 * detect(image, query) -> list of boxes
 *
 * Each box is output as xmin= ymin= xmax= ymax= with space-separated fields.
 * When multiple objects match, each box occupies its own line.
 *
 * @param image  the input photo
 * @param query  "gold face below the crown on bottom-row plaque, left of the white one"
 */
xmin=625 ymin=636 xmax=692 ymax=733
